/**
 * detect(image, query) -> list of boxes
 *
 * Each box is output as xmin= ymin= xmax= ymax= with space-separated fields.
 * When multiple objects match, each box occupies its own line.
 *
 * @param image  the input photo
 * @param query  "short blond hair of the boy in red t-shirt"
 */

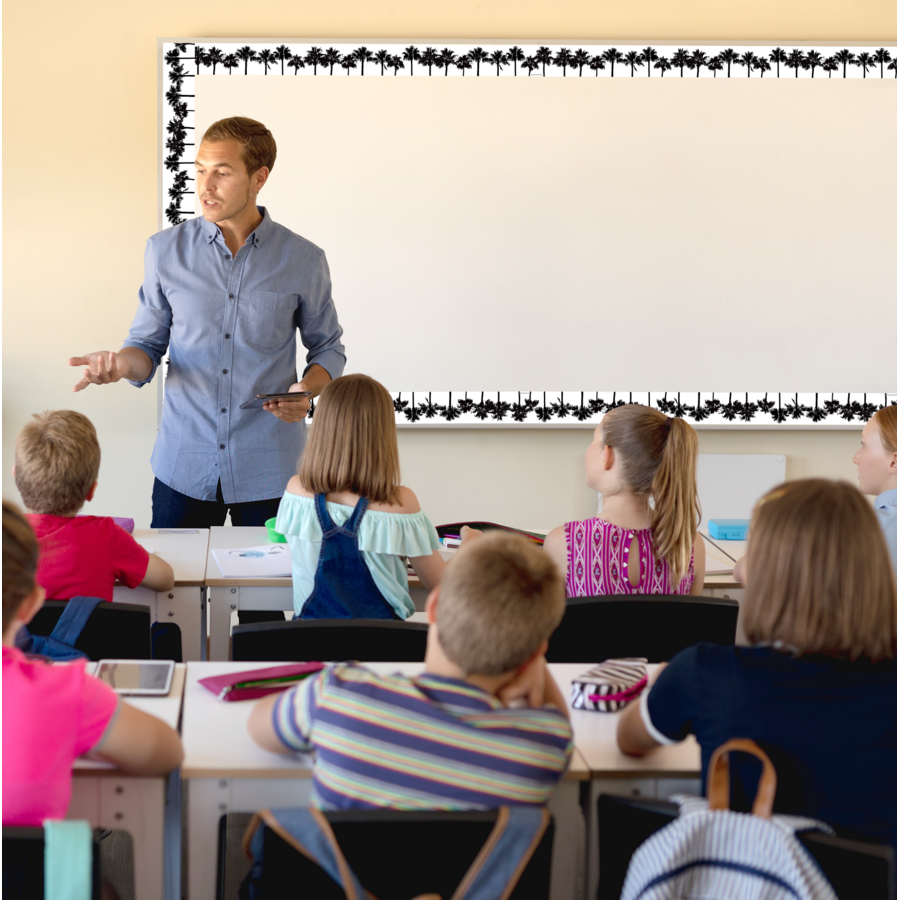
xmin=16 ymin=409 xmax=100 ymax=516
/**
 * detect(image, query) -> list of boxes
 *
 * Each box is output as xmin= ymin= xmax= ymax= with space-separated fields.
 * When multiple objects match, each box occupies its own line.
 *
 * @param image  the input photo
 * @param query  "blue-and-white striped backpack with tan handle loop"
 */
xmin=622 ymin=739 xmax=837 ymax=900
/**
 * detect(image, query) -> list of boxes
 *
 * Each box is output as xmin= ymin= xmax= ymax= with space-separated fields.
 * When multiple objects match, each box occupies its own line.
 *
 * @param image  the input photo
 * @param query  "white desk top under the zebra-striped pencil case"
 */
xmin=550 ymin=663 xmax=700 ymax=778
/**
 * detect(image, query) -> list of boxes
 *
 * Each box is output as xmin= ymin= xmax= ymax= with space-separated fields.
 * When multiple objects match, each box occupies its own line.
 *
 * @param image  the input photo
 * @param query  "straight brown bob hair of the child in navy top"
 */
xmin=744 ymin=478 xmax=897 ymax=662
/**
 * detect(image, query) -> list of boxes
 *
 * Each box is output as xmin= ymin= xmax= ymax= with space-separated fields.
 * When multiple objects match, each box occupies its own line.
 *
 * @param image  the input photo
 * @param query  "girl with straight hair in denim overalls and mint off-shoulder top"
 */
xmin=275 ymin=375 xmax=444 ymax=619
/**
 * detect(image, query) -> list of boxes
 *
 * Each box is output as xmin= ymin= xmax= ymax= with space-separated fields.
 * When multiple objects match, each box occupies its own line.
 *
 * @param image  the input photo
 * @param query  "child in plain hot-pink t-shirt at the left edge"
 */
xmin=3 ymin=501 xmax=183 ymax=826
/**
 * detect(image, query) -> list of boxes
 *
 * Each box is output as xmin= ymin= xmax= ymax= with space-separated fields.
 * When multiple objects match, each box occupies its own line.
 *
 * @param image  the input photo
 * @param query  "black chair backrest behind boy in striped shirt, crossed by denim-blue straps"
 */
xmin=230 ymin=809 xmax=553 ymax=900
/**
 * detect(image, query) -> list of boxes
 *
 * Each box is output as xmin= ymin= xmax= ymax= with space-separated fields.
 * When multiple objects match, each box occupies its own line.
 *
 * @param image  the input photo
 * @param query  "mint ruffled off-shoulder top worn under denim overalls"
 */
xmin=275 ymin=491 xmax=441 ymax=619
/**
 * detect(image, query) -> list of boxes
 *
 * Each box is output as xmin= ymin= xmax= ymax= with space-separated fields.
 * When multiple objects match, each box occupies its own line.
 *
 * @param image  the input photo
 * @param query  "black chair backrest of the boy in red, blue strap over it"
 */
xmin=28 ymin=600 xmax=150 ymax=661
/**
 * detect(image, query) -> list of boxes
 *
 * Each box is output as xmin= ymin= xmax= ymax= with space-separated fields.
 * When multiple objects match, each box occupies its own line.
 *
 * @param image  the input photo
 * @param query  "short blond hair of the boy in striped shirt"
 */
xmin=437 ymin=531 xmax=566 ymax=675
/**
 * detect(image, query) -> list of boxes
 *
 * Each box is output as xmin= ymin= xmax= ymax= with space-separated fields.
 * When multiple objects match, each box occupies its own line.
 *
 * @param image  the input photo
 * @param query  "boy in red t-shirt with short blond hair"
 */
xmin=13 ymin=409 xmax=175 ymax=600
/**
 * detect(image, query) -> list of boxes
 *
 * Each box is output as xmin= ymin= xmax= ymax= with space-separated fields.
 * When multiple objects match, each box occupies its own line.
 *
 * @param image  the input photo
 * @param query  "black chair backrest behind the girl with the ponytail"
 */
xmin=547 ymin=594 xmax=738 ymax=662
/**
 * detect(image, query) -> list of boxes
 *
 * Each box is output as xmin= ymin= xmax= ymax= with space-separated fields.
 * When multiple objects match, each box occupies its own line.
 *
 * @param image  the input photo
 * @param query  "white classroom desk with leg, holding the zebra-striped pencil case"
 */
xmin=550 ymin=663 xmax=701 ymax=900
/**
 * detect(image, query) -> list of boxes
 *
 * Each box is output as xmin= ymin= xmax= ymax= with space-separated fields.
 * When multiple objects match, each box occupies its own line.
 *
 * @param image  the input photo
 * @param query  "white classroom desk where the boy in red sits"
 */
xmin=113 ymin=528 xmax=209 ymax=661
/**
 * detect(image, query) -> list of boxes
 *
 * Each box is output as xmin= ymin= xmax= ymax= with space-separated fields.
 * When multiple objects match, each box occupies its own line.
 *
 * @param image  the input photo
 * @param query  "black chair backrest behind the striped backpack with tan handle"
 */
xmin=597 ymin=794 xmax=896 ymax=900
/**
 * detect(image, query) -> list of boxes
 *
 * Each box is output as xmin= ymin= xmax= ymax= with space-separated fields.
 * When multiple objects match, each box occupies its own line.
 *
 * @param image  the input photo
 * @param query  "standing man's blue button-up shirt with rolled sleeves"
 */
xmin=124 ymin=207 xmax=346 ymax=503
